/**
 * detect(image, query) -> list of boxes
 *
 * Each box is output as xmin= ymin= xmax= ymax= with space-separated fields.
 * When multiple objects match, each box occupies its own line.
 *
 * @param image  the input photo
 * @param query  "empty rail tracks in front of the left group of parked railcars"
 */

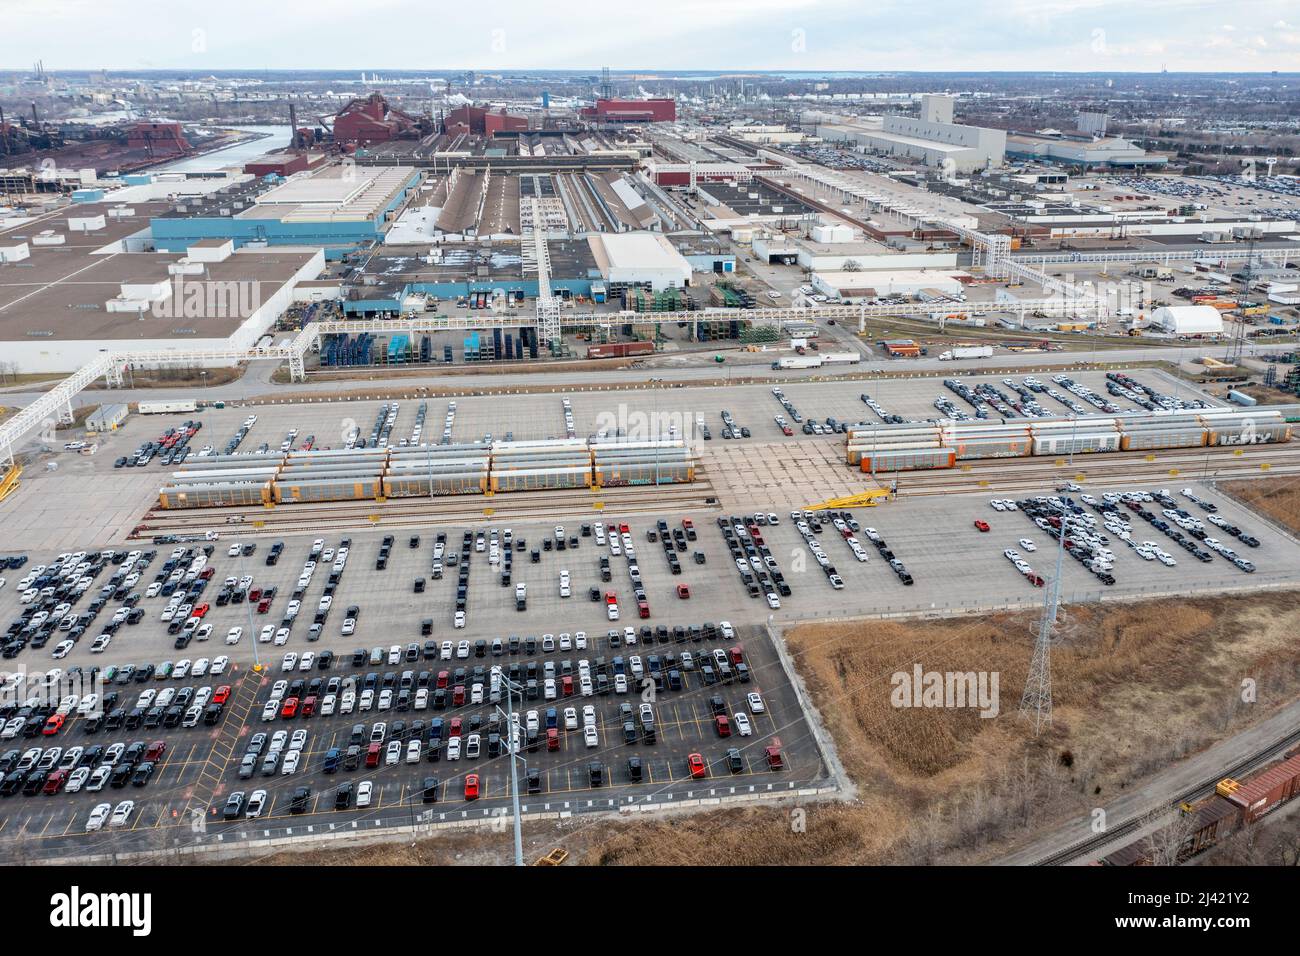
xmin=131 ymin=479 xmax=716 ymax=538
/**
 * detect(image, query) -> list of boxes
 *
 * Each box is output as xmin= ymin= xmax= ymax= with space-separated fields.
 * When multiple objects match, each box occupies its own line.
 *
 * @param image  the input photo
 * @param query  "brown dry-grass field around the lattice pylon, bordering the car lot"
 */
xmin=208 ymin=592 xmax=1300 ymax=865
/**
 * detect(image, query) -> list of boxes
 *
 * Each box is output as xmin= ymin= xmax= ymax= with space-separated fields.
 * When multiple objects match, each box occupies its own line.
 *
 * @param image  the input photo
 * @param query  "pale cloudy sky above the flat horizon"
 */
xmin=0 ymin=0 xmax=1300 ymax=73
